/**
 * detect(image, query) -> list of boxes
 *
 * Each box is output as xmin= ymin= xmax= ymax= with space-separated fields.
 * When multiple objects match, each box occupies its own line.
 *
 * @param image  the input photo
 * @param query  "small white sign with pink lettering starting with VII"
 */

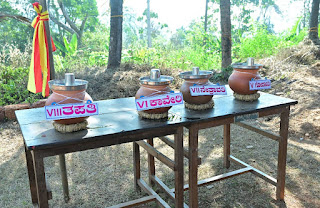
xmin=190 ymin=85 xmax=227 ymax=96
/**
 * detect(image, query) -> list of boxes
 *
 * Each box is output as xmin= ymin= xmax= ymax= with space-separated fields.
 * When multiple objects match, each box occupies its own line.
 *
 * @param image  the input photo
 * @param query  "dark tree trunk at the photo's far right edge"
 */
xmin=309 ymin=0 xmax=320 ymax=42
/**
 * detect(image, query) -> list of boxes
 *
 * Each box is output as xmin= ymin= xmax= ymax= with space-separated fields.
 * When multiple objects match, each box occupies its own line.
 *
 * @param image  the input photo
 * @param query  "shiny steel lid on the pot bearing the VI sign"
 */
xmin=139 ymin=69 xmax=173 ymax=85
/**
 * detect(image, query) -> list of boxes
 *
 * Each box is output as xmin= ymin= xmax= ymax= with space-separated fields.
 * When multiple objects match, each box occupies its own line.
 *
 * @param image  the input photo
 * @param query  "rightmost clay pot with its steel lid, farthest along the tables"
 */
xmin=228 ymin=58 xmax=262 ymax=95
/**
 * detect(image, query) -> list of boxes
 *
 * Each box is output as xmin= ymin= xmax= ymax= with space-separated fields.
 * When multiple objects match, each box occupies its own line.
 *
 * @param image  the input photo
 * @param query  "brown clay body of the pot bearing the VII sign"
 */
xmin=180 ymin=79 xmax=213 ymax=105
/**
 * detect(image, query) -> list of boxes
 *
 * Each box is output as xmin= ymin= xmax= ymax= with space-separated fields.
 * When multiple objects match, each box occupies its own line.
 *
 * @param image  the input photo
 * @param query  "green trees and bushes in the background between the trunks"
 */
xmin=0 ymin=0 xmax=310 ymax=105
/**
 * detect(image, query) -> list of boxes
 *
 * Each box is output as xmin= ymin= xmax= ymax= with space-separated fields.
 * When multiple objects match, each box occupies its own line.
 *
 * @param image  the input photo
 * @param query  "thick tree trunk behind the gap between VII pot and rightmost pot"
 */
xmin=220 ymin=0 xmax=232 ymax=69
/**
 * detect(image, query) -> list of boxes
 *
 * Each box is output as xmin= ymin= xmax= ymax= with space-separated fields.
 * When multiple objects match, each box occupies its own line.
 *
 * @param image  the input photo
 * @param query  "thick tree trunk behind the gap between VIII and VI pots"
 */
xmin=108 ymin=0 xmax=123 ymax=68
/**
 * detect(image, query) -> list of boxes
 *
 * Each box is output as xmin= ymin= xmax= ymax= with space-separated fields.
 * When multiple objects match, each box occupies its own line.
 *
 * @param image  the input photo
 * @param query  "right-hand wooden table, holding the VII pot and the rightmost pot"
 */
xmin=171 ymin=88 xmax=298 ymax=208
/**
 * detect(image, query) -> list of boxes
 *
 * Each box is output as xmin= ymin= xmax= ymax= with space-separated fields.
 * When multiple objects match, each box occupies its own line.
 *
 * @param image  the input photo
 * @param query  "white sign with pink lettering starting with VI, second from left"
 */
xmin=136 ymin=93 xmax=183 ymax=111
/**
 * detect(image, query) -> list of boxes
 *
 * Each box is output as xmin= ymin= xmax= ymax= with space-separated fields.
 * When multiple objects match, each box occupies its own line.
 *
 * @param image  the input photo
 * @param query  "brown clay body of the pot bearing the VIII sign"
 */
xmin=45 ymin=90 xmax=92 ymax=124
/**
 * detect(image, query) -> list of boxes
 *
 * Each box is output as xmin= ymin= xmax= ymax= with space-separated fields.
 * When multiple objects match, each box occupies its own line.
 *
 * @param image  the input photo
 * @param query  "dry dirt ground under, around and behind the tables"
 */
xmin=0 ymin=42 xmax=320 ymax=208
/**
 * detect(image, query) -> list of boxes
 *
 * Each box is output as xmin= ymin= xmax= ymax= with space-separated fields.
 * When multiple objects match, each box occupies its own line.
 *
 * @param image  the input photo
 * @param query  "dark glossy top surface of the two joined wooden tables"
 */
xmin=16 ymin=91 xmax=297 ymax=149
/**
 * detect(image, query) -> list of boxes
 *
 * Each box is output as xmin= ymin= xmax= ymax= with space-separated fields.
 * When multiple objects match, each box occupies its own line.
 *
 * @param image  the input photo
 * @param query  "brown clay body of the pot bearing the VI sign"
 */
xmin=135 ymin=84 xmax=171 ymax=114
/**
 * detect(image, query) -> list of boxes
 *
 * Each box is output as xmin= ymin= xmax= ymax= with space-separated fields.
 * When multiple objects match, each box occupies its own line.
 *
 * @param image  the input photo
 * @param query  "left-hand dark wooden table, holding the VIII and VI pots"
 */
xmin=16 ymin=98 xmax=188 ymax=208
